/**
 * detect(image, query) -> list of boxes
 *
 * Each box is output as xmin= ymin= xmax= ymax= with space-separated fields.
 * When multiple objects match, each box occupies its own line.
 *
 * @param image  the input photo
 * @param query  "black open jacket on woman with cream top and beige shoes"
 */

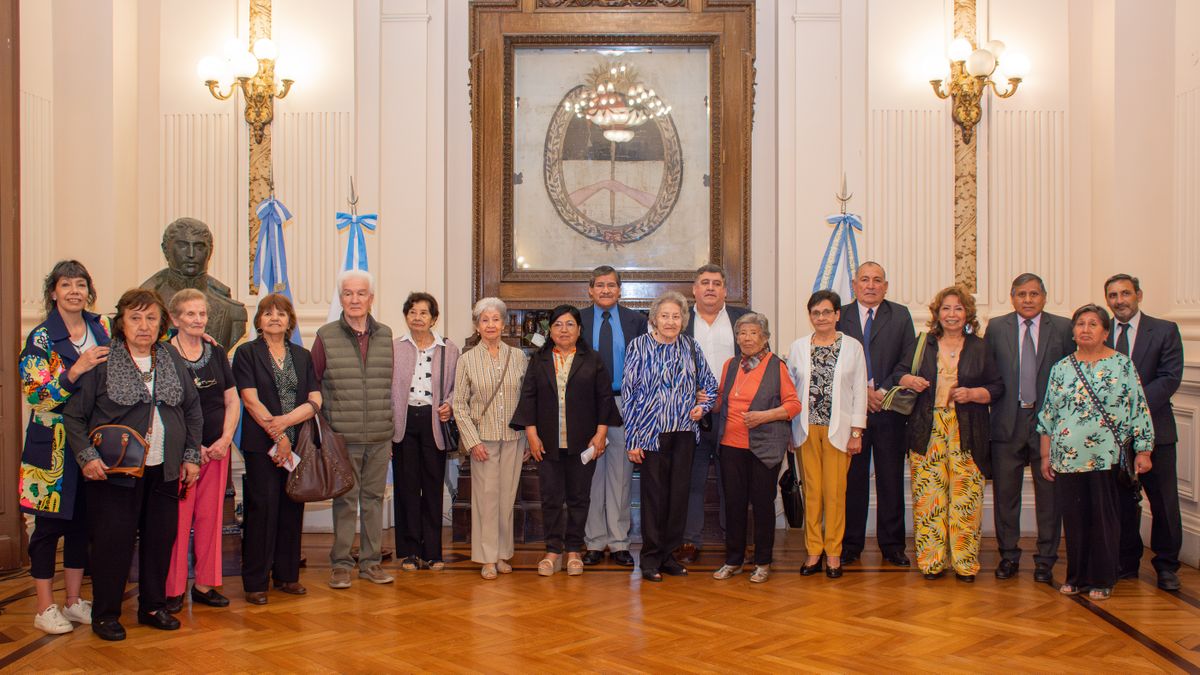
xmin=509 ymin=340 xmax=623 ymax=460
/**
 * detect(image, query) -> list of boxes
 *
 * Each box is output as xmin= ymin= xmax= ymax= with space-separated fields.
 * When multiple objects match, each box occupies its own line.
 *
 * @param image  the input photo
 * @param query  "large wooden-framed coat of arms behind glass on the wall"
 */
xmin=470 ymin=0 xmax=754 ymax=309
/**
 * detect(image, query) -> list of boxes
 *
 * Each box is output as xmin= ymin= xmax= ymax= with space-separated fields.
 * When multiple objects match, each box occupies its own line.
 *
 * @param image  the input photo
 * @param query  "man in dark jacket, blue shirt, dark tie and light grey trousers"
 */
xmin=580 ymin=265 xmax=646 ymax=567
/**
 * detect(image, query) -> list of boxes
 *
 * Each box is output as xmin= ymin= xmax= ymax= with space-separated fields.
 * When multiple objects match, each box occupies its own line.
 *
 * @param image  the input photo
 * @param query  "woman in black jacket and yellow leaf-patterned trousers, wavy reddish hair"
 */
xmin=894 ymin=286 xmax=1004 ymax=583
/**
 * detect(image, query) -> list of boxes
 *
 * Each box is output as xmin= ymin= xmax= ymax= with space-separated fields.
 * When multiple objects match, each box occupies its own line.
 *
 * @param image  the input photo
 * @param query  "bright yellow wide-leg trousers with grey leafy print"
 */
xmin=908 ymin=408 xmax=984 ymax=574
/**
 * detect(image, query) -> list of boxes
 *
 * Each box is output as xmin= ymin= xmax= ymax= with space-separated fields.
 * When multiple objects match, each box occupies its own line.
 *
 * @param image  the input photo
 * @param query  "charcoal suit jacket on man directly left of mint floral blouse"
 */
xmin=983 ymin=312 xmax=1075 ymax=443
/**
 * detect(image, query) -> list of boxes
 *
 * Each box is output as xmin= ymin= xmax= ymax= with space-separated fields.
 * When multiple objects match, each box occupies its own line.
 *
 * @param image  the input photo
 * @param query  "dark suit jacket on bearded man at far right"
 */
xmin=1109 ymin=313 xmax=1183 ymax=446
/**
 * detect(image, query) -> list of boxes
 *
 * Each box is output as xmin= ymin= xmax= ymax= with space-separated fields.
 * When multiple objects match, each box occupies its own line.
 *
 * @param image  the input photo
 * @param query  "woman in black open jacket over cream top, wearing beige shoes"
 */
xmin=510 ymin=305 xmax=622 ymax=577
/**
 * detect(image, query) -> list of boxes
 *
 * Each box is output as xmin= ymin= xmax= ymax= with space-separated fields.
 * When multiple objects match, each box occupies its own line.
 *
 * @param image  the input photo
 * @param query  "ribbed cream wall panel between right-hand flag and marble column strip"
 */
xmin=859 ymin=108 xmax=954 ymax=303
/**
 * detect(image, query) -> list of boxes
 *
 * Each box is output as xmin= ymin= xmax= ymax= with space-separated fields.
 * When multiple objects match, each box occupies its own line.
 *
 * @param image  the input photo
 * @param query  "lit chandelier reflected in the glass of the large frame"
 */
xmin=563 ymin=61 xmax=671 ymax=143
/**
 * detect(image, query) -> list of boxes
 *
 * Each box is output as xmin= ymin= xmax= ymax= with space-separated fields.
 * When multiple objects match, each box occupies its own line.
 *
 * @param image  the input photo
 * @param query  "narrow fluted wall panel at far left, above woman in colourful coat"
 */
xmin=20 ymin=91 xmax=55 ymax=314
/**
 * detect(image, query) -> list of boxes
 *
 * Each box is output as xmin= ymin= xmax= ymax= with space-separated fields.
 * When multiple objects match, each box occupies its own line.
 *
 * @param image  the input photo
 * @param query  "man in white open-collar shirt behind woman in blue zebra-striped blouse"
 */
xmin=676 ymin=263 xmax=750 ymax=565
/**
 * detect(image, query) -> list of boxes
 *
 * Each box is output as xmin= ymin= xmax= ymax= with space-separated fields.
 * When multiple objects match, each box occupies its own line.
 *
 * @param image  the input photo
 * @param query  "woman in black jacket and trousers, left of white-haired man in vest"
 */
xmin=233 ymin=293 xmax=320 ymax=604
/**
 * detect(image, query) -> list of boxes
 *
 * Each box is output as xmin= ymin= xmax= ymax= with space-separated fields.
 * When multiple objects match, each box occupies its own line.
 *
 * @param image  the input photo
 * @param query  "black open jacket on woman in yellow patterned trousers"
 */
xmin=892 ymin=333 xmax=1004 ymax=478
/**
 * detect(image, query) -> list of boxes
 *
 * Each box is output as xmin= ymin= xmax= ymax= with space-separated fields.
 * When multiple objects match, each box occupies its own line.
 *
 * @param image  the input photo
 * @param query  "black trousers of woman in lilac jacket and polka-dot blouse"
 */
xmin=391 ymin=406 xmax=446 ymax=562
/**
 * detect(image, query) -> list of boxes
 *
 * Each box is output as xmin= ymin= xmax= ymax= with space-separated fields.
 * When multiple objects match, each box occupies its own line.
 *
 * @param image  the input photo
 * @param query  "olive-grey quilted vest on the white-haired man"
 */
xmin=317 ymin=317 xmax=394 ymax=444
